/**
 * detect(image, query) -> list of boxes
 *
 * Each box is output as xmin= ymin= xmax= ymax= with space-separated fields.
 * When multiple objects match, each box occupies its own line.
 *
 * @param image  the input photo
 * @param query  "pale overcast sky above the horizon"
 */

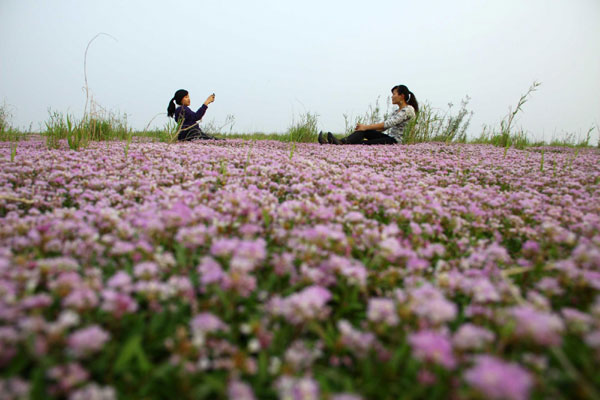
xmin=0 ymin=0 xmax=600 ymax=140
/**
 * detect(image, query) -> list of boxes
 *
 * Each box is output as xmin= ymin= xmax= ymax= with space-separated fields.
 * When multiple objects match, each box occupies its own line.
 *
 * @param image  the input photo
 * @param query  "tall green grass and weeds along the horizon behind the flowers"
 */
xmin=0 ymin=82 xmax=600 ymax=150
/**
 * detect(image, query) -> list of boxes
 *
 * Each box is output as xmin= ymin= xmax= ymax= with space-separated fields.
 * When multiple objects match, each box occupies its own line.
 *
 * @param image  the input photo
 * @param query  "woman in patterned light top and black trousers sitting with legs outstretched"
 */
xmin=318 ymin=85 xmax=419 ymax=144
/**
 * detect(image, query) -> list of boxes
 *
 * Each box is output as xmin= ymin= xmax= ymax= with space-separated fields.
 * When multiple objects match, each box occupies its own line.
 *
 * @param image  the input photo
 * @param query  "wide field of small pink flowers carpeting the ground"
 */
xmin=0 ymin=140 xmax=600 ymax=400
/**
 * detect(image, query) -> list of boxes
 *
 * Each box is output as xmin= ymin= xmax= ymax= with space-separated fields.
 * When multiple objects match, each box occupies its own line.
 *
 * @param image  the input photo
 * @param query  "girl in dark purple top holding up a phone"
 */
xmin=167 ymin=89 xmax=216 ymax=140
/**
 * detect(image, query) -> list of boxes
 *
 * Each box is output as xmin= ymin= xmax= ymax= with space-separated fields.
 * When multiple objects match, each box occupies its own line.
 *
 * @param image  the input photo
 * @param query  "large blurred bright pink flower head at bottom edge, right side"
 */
xmin=464 ymin=355 xmax=533 ymax=400
